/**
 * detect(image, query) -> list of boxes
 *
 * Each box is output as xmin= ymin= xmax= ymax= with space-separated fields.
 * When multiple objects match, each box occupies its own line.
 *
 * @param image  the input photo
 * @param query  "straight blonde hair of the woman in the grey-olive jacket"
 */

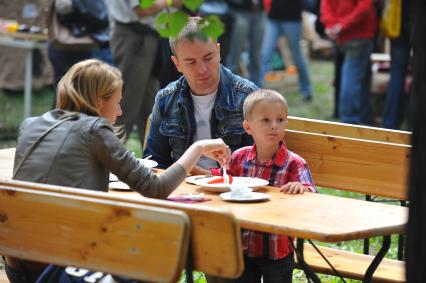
xmin=56 ymin=59 xmax=123 ymax=116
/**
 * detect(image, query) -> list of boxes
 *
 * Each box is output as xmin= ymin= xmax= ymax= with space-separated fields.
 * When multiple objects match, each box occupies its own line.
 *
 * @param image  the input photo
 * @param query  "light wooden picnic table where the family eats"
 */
xmin=0 ymin=149 xmax=408 ymax=282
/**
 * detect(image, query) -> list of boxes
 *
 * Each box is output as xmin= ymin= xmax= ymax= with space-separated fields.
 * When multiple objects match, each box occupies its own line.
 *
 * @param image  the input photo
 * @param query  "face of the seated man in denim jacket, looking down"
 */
xmin=172 ymin=39 xmax=220 ymax=95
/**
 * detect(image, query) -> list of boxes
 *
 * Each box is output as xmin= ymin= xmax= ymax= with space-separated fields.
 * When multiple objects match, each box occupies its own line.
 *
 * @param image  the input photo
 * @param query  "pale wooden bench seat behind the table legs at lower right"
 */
xmin=298 ymin=244 xmax=406 ymax=283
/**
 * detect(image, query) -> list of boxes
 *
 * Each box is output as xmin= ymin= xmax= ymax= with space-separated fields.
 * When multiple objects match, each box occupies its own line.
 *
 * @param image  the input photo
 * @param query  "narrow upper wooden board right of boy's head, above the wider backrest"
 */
xmin=288 ymin=116 xmax=411 ymax=145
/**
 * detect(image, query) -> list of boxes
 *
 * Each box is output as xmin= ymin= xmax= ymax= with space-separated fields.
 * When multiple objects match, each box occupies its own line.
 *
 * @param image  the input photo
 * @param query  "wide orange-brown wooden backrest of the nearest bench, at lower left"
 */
xmin=0 ymin=184 xmax=190 ymax=282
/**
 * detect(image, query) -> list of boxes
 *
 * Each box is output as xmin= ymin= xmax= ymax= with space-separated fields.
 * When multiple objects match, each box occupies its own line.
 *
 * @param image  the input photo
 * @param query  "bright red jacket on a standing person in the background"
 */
xmin=320 ymin=0 xmax=378 ymax=43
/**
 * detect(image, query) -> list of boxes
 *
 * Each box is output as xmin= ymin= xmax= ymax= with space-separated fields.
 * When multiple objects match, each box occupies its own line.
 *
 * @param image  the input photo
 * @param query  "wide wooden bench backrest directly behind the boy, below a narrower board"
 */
xmin=285 ymin=130 xmax=411 ymax=200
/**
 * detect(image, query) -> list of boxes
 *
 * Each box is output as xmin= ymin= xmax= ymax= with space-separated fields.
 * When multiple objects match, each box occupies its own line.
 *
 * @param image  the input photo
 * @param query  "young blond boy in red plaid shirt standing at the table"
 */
xmin=212 ymin=89 xmax=316 ymax=283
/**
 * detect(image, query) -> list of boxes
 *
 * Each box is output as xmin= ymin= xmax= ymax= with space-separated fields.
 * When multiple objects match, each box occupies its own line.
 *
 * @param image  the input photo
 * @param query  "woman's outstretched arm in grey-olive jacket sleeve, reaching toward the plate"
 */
xmin=92 ymin=122 xmax=230 ymax=199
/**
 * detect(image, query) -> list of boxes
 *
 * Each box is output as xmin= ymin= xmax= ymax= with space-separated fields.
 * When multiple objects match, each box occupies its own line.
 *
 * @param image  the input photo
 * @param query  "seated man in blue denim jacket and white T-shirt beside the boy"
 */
xmin=144 ymin=18 xmax=258 ymax=174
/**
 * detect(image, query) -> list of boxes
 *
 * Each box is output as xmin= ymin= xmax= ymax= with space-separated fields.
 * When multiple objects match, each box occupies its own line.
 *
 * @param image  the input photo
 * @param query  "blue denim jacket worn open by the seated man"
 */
xmin=144 ymin=66 xmax=258 ymax=168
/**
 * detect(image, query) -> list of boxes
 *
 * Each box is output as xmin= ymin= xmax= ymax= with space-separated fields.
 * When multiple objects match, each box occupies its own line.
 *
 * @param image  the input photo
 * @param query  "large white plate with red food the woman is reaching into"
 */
xmin=194 ymin=176 xmax=269 ymax=193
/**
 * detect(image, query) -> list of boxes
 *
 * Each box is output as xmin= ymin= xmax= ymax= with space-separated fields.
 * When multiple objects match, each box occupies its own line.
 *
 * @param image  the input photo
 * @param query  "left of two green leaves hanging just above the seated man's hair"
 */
xmin=155 ymin=11 xmax=188 ymax=37
